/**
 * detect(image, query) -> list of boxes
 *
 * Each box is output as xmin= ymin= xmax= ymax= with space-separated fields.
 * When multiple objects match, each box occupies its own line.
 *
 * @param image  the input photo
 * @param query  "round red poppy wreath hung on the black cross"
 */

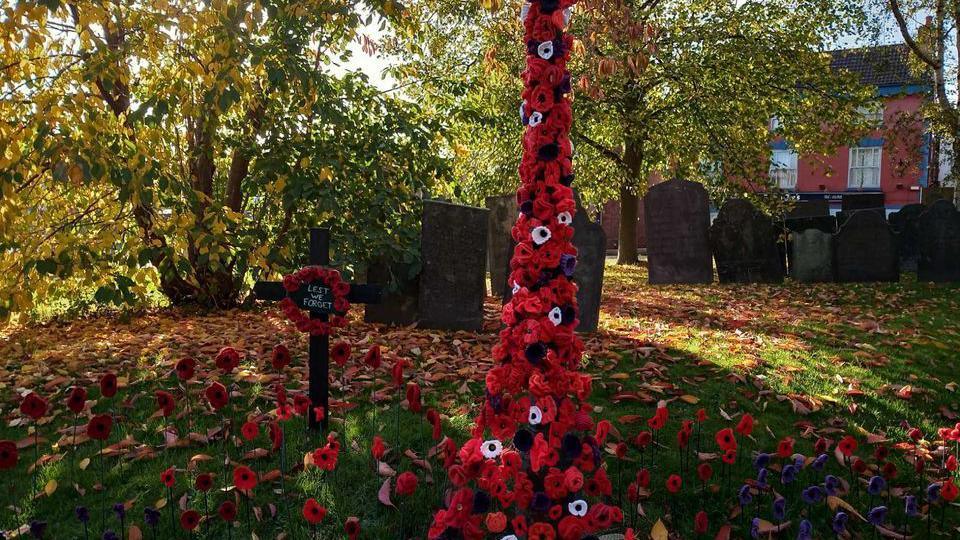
xmin=280 ymin=266 xmax=350 ymax=336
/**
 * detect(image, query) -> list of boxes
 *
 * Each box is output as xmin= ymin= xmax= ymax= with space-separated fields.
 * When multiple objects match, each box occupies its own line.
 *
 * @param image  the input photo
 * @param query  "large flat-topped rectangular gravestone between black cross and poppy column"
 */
xmin=418 ymin=200 xmax=489 ymax=330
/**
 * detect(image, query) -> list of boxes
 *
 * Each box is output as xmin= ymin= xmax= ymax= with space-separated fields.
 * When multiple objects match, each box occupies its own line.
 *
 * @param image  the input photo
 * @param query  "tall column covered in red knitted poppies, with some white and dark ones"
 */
xmin=429 ymin=0 xmax=623 ymax=540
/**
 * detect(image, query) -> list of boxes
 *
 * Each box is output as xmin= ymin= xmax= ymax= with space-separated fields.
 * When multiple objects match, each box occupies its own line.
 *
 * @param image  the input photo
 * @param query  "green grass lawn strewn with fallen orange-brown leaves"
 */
xmin=0 ymin=266 xmax=960 ymax=539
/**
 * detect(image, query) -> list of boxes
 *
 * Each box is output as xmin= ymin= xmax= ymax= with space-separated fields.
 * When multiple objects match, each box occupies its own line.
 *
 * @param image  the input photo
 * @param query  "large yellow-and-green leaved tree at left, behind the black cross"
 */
xmin=0 ymin=0 xmax=444 ymax=313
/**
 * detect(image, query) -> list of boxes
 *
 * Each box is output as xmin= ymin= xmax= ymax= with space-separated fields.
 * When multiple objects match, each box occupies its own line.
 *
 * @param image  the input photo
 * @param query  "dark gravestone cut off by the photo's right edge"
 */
xmin=917 ymin=199 xmax=960 ymax=282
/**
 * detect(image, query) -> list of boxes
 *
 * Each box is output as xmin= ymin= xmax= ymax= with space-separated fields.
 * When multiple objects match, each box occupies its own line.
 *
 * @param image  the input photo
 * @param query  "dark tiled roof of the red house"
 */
xmin=830 ymin=43 xmax=930 ymax=87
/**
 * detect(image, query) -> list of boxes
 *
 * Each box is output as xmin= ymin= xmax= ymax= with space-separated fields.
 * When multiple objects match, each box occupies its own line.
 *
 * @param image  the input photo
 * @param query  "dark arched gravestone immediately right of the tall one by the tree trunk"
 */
xmin=710 ymin=199 xmax=783 ymax=283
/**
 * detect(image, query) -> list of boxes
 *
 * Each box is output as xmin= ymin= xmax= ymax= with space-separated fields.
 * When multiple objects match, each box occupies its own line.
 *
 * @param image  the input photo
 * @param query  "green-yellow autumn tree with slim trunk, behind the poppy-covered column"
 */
xmin=382 ymin=0 xmax=871 ymax=263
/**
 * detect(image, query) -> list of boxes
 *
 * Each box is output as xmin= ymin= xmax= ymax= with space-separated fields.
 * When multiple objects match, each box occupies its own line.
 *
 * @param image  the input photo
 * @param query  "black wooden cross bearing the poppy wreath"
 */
xmin=253 ymin=228 xmax=383 ymax=431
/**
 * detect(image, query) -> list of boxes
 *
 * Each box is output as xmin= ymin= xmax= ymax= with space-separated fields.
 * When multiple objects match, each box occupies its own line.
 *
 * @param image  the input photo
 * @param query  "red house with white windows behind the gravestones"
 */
xmin=601 ymin=44 xmax=932 ymax=249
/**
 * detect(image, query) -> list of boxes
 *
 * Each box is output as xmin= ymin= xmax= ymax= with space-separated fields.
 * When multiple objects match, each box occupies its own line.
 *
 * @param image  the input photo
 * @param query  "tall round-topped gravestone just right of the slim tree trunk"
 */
xmin=643 ymin=179 xmax=713 ymax=285
